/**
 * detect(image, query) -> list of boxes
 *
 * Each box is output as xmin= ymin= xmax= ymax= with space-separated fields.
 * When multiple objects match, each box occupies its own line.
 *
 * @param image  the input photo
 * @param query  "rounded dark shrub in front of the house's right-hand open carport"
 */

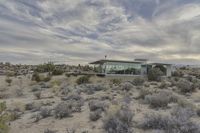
xmin=147 ymin=68 xmax=163 ymax=81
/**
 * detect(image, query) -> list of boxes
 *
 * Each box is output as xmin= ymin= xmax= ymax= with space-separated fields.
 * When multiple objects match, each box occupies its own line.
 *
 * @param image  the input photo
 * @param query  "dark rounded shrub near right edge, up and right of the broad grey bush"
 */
xmin=177 ymin=79 xmax=195 ymax=93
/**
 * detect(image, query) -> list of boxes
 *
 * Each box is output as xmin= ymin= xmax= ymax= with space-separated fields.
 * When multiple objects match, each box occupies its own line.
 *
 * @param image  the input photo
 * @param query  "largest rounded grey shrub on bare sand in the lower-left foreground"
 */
xmin=54 ymin=102 xmax=72 ymax=119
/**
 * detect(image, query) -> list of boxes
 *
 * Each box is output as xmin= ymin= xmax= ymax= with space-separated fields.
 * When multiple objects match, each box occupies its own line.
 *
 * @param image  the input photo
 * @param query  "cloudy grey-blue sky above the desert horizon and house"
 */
xmin=0 ymin=0 xmax=200 ymax=64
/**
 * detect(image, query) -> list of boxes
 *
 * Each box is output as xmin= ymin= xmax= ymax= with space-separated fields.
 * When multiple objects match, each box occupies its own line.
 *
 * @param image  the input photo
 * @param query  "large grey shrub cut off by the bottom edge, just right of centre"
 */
xmin=103 ymin=107 xmax=133 ymax=133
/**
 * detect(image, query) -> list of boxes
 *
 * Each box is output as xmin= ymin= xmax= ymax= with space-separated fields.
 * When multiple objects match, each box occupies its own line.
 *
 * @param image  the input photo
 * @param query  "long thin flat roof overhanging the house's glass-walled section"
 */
xmin=89 ymin=60 xmax=144 ymax=64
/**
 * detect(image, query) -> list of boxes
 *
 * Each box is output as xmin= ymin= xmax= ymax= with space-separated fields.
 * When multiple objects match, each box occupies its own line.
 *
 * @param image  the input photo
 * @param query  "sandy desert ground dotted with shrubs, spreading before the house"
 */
xmin=0 ymin=69 xmax=200 ymax=133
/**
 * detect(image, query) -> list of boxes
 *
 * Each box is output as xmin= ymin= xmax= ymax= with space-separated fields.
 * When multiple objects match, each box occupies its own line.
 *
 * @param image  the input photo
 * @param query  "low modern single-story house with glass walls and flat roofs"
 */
xmin=90 ymin=59 xmax=172 ymax=76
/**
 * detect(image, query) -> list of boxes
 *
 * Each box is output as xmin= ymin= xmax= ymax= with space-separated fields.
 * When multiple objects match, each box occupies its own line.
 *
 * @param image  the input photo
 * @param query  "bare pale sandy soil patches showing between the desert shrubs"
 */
xmin=0 ymin=76 xmax=200 ymax=133
